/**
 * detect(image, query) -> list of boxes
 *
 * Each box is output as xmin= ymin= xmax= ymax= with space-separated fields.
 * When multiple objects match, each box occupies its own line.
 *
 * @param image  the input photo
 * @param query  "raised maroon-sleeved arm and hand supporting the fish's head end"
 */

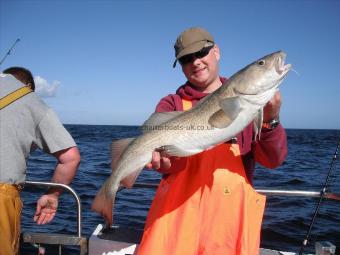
xmin=252 ymin=91 xmax=287 ymax=169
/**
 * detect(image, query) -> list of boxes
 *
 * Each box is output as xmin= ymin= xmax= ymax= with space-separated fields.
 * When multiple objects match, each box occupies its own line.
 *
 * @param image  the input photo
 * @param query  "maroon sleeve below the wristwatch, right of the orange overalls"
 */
xmin=252 ymin=124 xmax=287 ymax=169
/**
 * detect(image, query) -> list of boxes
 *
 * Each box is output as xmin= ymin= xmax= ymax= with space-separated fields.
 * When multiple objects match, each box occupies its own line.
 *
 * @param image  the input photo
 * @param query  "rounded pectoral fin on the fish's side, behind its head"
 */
xmin=208 ymin=97 xmax=241 ymax=128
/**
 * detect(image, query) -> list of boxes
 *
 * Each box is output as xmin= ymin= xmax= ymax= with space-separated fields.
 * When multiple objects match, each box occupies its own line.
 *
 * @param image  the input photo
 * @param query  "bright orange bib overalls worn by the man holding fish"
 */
xmin=137 ymin=98 xmax=266 ymax=255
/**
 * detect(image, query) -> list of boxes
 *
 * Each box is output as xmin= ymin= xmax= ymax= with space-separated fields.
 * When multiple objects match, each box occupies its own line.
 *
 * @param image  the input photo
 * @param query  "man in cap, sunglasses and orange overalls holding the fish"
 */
xmin=138 ymin=28 xmax=287 ymax=255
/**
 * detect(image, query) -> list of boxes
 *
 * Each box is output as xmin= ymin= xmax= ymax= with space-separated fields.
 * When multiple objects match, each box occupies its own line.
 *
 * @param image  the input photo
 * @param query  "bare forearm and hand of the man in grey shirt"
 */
xmin=33 ymin=147 xmax=80 ymax=225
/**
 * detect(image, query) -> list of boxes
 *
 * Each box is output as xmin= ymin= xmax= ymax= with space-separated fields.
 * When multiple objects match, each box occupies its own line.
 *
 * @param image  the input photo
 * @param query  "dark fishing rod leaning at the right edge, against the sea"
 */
xmin=299 ymin=140 xmax=340 ymax=255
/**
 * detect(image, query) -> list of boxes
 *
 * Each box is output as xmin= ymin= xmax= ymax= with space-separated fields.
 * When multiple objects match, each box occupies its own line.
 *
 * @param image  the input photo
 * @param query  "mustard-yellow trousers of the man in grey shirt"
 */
xmin=0 ymin=183 xmax=22 ymax=255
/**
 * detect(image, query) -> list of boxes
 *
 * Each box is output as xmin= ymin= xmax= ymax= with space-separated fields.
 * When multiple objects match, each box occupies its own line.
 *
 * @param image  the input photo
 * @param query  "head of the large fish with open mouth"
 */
xmin=231 ymin=51 xmax=291 ymax=95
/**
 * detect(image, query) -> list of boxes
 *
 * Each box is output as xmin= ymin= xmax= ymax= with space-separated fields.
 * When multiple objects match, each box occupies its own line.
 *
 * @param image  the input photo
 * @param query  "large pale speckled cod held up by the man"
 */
xmin=92 ymin=51 xmax=291 ymax=225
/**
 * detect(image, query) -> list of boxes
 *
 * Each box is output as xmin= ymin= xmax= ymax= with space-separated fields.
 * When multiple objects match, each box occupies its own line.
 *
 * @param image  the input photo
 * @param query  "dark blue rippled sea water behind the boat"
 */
xmin=21 ymin=125 xmax=340 ymax=254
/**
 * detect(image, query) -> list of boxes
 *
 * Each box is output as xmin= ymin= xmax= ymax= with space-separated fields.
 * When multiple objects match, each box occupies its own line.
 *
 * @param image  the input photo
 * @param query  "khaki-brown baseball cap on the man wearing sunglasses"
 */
xmin=173 ymin=27 xmax=214 ymax=67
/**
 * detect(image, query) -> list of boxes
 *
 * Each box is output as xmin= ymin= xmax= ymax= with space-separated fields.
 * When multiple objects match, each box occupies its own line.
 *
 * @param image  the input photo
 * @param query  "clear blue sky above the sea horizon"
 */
xmin=0 ymin=0 xmax=340 ymax=129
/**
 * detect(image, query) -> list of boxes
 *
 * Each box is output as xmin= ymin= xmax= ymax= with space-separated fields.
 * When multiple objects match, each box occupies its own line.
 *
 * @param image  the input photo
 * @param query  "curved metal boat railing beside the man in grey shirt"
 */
xmin=22 ymin=181 xmax=87 ymax=255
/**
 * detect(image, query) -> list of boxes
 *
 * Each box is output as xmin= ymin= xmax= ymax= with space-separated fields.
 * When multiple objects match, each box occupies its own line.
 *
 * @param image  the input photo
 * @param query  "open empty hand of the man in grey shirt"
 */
xmin=33 ymin=194 xmax=58 ymax=225
